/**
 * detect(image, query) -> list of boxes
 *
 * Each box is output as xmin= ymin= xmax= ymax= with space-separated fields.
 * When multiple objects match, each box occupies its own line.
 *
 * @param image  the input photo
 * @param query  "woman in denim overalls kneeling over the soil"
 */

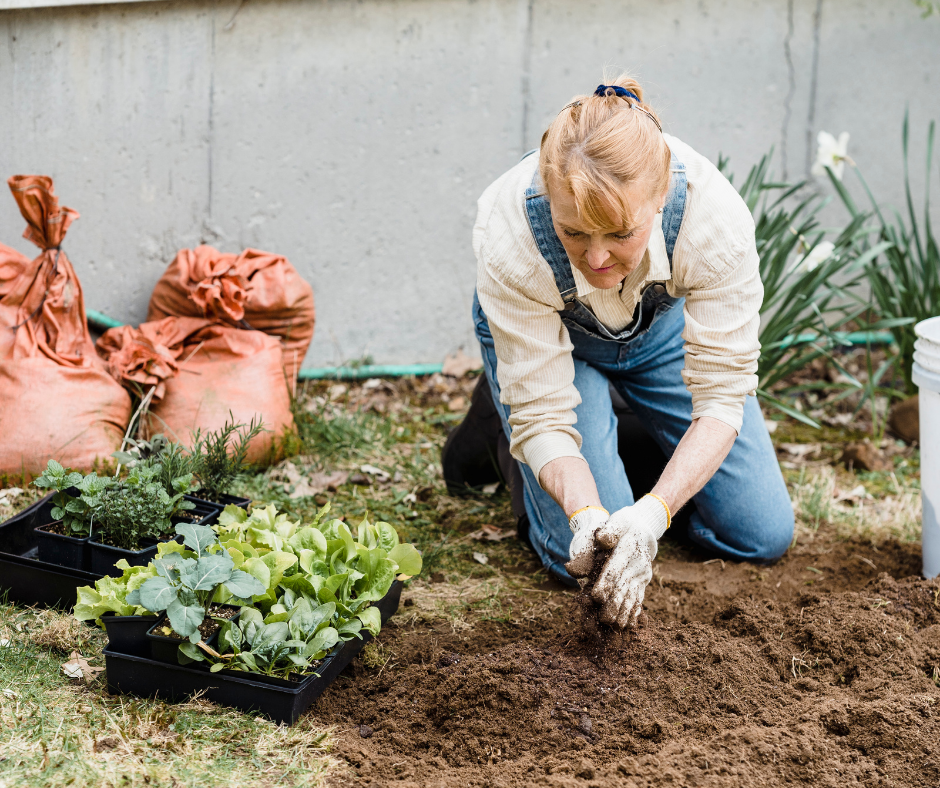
xmin=443 ymin=76 xmax=793 ymax=628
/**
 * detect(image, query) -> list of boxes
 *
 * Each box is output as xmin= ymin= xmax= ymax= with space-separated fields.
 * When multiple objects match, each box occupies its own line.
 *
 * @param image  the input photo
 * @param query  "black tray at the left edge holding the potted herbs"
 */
xmin=0 ymin=494 xmax=99 ymax=610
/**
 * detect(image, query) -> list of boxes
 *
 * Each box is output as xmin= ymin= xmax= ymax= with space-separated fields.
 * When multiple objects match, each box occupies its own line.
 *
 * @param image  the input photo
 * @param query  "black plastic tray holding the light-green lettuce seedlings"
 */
xmin=104 ymin=580 xmax=402 ymax=725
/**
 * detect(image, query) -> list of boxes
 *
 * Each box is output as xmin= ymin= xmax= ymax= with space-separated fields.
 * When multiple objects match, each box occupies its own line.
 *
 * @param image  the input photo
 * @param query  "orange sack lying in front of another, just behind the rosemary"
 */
xmin=98 ymin=317 xmax=294 ymax=463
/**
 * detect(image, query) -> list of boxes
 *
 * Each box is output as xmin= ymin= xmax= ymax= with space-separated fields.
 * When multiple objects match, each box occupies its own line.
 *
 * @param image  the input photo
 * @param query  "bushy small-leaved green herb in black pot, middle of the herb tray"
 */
xmin=89 ymin=463 xmax=194 ymax=576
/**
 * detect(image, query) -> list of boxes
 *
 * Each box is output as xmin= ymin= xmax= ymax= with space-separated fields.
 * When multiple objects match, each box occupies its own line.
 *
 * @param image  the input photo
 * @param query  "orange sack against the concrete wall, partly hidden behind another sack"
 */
xmin=147 ymin=246 xmax=315 ymax=385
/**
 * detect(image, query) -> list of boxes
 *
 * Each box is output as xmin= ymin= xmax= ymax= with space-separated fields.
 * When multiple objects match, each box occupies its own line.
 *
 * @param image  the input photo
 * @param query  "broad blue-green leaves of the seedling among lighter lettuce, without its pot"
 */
xmin=127 ymin=523 xmax=266 ymax=643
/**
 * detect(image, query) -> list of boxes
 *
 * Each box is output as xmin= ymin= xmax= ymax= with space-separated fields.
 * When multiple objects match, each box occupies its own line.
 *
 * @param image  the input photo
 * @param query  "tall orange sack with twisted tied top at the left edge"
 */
xmin=0 ymin=175 xmax=131 ymax=478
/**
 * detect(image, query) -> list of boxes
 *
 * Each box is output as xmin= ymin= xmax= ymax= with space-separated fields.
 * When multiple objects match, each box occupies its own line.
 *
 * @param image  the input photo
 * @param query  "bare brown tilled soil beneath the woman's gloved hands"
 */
xmin=310 ymin=538 xmax=940 ymax=788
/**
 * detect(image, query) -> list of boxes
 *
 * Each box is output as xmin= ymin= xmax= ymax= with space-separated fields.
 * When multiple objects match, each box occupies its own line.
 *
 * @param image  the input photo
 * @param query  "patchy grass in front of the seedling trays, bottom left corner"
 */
xmin=0 ymin=604 xmax=329 ymax=788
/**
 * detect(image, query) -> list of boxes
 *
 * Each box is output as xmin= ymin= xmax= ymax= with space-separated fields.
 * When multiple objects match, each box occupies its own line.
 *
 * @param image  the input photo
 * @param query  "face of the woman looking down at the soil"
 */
xmin=551 ymin=187 xmax=665 ymax=289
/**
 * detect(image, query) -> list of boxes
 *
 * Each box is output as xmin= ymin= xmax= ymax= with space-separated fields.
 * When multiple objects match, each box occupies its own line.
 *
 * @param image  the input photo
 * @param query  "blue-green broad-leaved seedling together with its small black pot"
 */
xmin=127 ymin=523 xmax=267 ymax=662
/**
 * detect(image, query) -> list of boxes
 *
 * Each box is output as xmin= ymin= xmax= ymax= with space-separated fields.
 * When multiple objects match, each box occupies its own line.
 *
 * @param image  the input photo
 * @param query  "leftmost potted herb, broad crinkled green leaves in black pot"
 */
xmin=33 ymin=460 xmax=111 ymax=570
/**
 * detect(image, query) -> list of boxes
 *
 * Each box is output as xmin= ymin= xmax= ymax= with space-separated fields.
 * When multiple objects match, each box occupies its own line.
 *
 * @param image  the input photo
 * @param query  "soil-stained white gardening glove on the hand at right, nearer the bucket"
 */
xmin=591 ymin=495 xmax=671 ymax=629
